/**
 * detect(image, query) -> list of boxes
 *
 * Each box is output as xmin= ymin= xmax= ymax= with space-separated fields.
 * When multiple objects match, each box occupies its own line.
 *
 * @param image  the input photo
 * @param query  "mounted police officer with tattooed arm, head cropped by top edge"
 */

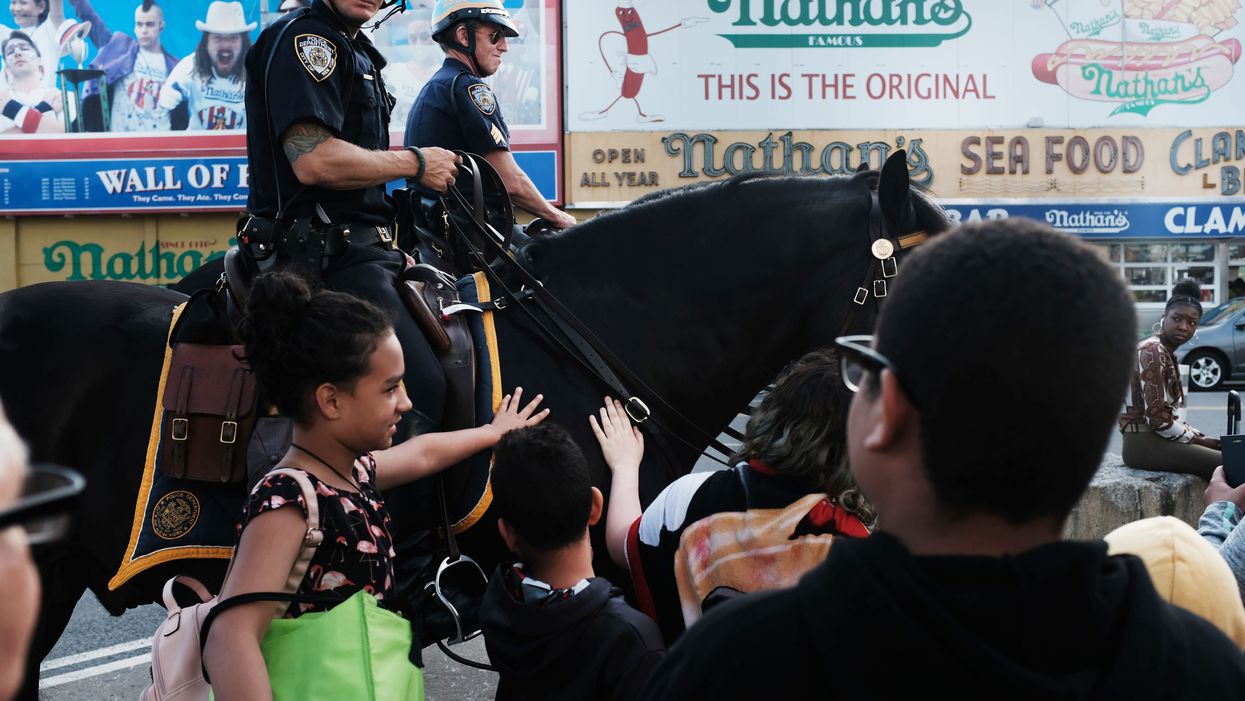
xmin=239 ymin=0 xmax=461 ymax=433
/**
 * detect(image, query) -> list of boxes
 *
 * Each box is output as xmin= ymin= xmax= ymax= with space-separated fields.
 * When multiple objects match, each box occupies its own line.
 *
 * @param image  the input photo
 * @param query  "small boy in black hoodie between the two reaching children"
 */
xmin=481 ymin=422 xmax=665 ymax=700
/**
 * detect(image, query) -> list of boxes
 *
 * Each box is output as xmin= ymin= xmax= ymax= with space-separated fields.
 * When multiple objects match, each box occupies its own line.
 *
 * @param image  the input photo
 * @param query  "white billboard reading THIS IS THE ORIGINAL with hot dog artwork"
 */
xmin=564 ymin=0 xmax=1245 ymax=133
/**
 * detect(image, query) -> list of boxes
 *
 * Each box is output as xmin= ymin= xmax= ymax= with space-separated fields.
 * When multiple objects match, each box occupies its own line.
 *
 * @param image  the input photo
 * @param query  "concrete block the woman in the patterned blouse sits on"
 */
xmin=1063 ymin=453 xmax=1206 ymax=540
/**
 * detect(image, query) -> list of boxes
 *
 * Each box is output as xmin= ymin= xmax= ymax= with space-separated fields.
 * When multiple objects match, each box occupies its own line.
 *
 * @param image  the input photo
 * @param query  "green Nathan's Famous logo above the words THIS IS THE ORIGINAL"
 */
xmin=706 ymin=0 xmax=972 ymax=49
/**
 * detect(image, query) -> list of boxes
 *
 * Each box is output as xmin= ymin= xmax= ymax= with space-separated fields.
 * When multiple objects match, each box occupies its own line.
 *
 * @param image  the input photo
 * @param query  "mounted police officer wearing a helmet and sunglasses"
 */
xmin=405 ymin=0 xmax=575 ymax=229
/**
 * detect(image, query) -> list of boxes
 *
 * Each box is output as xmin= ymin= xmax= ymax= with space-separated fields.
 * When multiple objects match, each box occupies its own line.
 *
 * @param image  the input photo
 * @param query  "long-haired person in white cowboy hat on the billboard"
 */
xmin=159 ymin=0 xmax=255 ymax=129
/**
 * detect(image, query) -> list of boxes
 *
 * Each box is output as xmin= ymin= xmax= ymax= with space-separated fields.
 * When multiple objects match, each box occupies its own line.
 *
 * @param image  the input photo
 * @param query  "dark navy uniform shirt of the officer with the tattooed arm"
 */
xmin=247 ymin=0 xmax=393 ymax=225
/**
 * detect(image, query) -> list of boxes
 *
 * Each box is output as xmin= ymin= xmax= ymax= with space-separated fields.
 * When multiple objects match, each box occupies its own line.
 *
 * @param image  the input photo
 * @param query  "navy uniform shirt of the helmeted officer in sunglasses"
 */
xmin=406 ymin=59 xmax=510 ymax=165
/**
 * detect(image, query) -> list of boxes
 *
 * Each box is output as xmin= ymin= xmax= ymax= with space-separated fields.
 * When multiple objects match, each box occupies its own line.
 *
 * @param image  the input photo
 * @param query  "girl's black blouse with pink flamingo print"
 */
xmin=238 ymin=454 xmax=393 ymax=618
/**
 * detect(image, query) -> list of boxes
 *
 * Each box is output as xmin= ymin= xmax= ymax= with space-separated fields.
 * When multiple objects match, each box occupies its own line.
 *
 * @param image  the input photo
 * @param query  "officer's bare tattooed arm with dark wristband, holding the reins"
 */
xmin=281 ymin=120 xmax=459 ymax=192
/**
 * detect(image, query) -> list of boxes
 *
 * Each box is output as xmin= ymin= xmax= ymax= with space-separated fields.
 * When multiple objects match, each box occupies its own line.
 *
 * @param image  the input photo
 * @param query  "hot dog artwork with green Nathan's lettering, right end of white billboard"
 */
xmin=1032 ymin=0 xmax=1241 ymax=117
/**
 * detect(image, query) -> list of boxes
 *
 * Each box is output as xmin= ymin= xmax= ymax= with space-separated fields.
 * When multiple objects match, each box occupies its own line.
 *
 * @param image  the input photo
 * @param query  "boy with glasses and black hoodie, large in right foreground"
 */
xmin=646 ymin=219 xmax=1245 ymax=699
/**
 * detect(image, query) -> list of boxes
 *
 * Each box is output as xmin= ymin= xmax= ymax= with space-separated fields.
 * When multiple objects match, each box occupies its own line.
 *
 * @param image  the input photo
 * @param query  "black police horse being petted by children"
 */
xmin=0 ymin=152 xmax=949 ymax=687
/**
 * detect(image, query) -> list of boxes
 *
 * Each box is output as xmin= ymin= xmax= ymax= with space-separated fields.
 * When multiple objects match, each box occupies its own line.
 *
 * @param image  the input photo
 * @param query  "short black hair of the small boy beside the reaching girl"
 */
xmin=492 ymin=421 xmax=593 ymax=550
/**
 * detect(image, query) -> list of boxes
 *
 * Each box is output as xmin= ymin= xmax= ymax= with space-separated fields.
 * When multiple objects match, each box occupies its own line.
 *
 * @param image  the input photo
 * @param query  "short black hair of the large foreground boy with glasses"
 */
xmin=876 ymin=218 xmax=1137 ymax=524
